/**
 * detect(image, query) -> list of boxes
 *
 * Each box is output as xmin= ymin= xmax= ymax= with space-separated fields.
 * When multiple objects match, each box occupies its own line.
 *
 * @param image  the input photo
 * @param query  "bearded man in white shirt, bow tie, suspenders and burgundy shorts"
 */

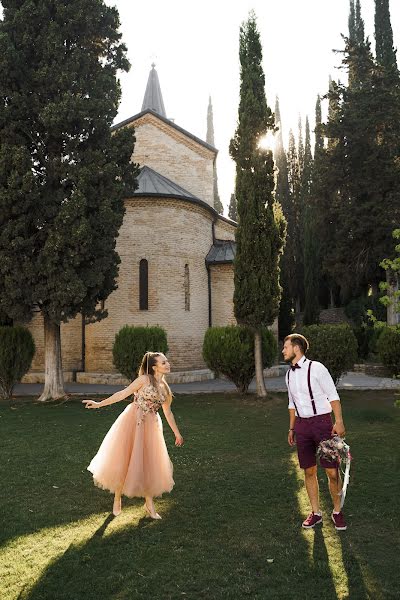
xmin=282 ymin=333 xmax=347 ymax=531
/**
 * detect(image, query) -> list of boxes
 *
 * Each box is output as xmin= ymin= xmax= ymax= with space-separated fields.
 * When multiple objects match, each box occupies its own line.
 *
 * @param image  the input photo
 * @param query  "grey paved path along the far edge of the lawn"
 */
xmin=14 ymin=373 xmax=400 ymax=396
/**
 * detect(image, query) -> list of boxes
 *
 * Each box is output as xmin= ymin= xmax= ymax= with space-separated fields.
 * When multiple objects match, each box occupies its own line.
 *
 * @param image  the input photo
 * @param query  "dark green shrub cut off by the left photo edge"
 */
xmin=0 ymin=325 xmax=35 ymax=399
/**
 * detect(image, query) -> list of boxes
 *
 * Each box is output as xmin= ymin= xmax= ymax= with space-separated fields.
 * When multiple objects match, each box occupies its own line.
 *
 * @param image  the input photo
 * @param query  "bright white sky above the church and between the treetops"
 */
xmin=107 ymin=0 xmax=400 ymax=214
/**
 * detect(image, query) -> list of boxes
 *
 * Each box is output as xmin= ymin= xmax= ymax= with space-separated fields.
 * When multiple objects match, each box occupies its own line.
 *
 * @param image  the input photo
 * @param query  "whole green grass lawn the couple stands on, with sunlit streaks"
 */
xmin=0 ymin=391 xmax=400 ymax=600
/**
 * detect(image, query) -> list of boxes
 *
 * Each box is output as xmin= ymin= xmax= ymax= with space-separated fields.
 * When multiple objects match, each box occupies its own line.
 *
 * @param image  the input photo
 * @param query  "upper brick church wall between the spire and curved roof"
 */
xmin=133 ymin=115 xmax=215 ymax=207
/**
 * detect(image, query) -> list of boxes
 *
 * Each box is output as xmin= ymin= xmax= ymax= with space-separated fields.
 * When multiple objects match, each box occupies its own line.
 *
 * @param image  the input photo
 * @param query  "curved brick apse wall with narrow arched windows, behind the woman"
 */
xmin=86 ymin=198 xmax=216 ymax=373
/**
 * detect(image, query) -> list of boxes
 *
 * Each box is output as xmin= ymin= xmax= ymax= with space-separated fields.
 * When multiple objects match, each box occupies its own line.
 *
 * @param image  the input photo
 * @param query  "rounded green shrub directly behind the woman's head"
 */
xmin=113 ymin=325 xmax=168 ymax=381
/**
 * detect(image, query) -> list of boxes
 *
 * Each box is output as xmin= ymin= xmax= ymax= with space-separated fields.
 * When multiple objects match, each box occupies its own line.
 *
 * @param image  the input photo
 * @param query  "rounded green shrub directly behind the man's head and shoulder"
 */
xmin=301 ymin=324 xmax=357 ymax=382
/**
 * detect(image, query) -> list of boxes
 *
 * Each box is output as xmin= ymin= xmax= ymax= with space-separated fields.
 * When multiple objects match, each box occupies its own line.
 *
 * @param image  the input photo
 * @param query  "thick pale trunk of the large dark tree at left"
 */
xmin=39 ymin=317 xmax=65 ymax=402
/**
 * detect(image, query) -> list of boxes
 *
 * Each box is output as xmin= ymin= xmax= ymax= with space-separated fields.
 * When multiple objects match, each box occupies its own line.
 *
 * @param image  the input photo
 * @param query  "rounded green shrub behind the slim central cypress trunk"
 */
xmin=203 ymin=325 xmax=277 ymax=393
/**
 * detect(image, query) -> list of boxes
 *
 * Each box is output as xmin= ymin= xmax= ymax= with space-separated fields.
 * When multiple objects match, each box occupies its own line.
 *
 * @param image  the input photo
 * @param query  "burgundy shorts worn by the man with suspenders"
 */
xmin=294 ymin=413 xmax=338 ymax=469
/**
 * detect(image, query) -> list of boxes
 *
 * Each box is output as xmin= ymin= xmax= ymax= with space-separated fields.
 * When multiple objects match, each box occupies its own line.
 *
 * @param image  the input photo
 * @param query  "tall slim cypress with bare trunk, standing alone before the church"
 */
xmin=230 ymin=13 xmax=285 ymax=396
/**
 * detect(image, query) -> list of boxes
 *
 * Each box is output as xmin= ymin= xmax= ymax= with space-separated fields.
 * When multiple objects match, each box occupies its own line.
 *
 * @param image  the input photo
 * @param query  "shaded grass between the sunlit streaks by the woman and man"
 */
xmin=16 ymin=404 xmax=336 ymax=600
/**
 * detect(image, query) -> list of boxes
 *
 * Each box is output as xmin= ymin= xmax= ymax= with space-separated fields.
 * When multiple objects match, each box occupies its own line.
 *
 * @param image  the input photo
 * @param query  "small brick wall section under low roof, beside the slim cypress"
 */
xmin=210 ymin=264 xmax=236 ymax=327
